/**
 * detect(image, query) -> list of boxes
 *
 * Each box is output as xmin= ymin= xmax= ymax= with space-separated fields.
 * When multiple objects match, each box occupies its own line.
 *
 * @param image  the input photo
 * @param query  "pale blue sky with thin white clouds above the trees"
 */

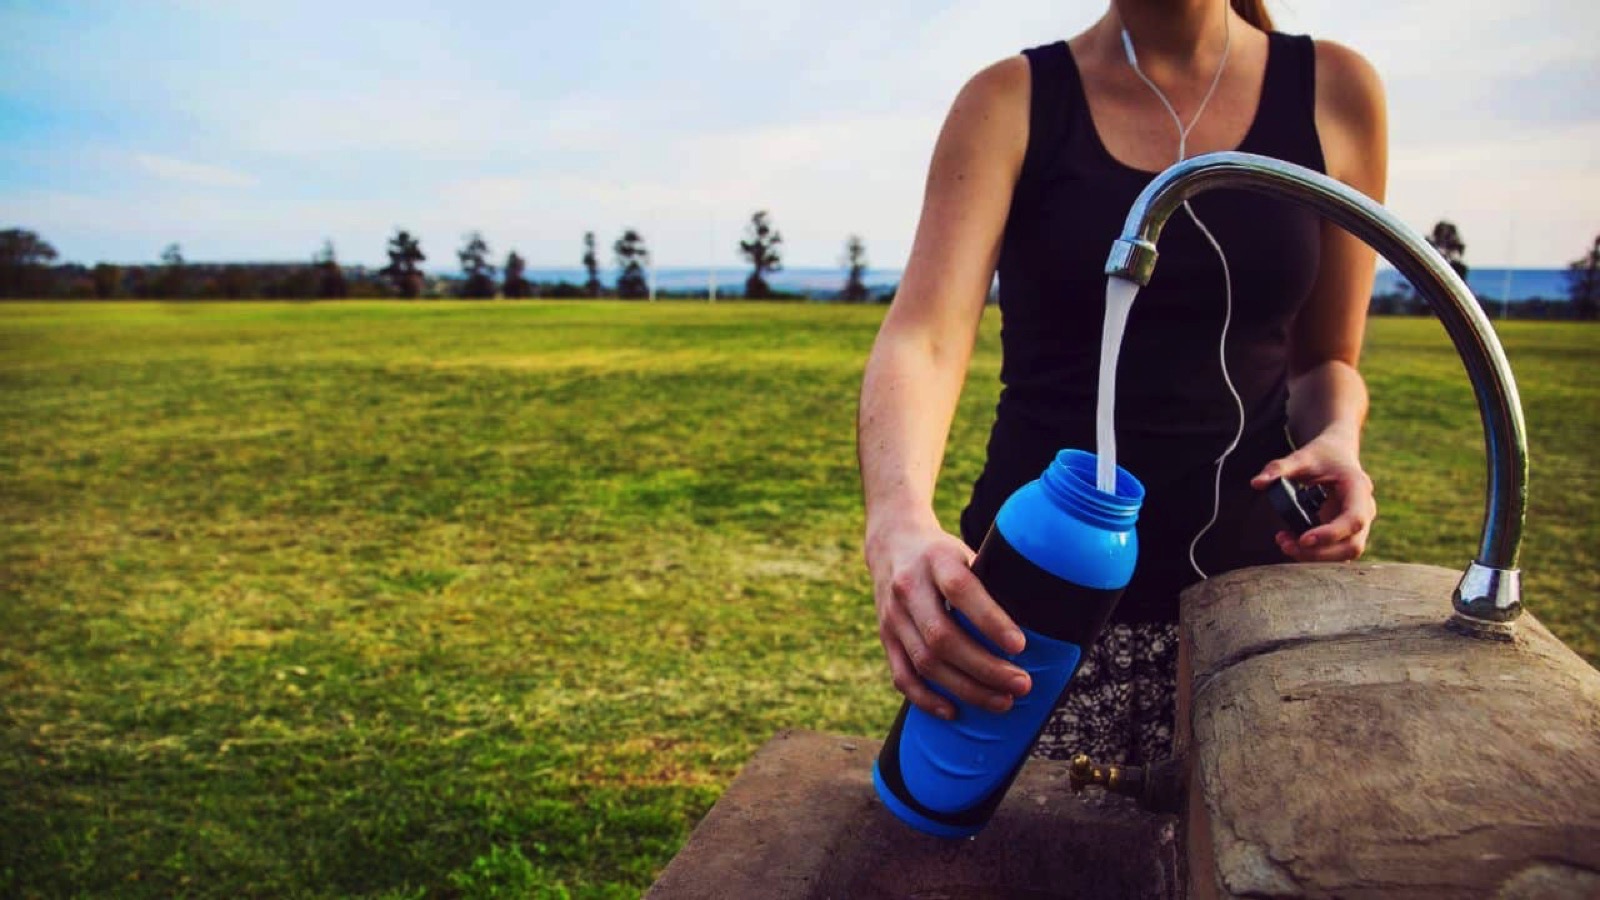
xmin=0 ymin=0 xmax=1600 ymax=267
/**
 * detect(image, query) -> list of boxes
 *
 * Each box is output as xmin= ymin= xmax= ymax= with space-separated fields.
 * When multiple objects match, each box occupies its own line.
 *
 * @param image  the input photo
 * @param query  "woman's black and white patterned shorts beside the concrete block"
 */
xmin=1034 ymin=623 xmax=1178 ymax=765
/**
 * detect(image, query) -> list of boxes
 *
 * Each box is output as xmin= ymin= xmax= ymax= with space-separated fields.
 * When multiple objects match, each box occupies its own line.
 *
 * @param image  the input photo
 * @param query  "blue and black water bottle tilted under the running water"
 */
xmin=872 ymin=450 xmax=1144 ymax=838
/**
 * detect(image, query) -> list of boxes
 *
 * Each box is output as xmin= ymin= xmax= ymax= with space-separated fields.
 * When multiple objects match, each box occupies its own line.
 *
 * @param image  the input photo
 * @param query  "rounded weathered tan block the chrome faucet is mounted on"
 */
xmin=1182 ymin=564 xmax=1600 ymax=898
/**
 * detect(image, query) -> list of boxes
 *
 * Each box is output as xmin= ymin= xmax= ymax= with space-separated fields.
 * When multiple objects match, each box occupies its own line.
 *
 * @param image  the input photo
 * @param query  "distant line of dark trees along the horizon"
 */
xmin=0 ymin=210 xmax=1600 ymax=320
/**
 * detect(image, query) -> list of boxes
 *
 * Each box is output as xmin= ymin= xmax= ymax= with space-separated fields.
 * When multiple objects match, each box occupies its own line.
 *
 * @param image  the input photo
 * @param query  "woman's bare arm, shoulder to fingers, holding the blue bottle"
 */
xmin=858 ymin=56 xmax=1030 ymax=717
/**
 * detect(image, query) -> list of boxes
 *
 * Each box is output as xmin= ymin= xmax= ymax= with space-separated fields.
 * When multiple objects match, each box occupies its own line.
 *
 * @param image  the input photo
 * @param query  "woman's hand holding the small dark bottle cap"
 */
xmin=1250 ymin=432 xmax=1378 ymax=562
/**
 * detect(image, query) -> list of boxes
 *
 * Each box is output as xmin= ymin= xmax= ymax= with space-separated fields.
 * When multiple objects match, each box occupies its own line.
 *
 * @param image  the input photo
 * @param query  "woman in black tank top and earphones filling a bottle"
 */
xmin=859 ymin=0 xmax=1386 ymax=762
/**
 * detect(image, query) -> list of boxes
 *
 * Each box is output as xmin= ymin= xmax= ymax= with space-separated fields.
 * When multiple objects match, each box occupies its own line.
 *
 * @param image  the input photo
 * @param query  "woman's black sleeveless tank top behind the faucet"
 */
xmin=962 ymin=34 xmax=1325 ymax=621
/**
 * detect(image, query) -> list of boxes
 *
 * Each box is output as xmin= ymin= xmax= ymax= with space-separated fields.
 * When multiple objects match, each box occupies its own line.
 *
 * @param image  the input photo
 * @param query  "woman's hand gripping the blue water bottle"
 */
xmin=867 ymin=515 xmax=1032 ymax=719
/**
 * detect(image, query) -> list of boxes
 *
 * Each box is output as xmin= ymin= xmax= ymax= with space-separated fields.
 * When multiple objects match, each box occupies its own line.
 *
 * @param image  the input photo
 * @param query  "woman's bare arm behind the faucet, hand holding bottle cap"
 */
xmin=1251 ymin=42 xmax=1389 ymax=562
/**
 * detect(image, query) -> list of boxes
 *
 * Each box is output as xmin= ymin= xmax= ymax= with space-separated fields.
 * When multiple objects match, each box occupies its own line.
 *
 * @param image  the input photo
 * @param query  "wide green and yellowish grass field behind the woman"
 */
xmin=0 ymin=303 xmax=1600 ymax=897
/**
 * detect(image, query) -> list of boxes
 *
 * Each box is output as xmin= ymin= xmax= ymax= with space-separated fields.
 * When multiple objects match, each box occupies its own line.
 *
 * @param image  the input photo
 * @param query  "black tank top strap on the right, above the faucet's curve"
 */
xmin=1242 ymin=32 xmax=1326 ymax=171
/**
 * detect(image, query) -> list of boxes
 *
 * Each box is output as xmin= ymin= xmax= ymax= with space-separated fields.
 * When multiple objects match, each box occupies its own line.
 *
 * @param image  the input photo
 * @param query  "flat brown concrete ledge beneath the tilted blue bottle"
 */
xmin=646 ymin=732 xmax=1178 ymax=900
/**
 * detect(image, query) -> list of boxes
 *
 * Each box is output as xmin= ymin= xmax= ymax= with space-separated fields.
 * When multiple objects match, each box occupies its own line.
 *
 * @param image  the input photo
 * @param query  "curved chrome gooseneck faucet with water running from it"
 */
xmin=1106 ymin=152 xmax=1528 ymax=631
